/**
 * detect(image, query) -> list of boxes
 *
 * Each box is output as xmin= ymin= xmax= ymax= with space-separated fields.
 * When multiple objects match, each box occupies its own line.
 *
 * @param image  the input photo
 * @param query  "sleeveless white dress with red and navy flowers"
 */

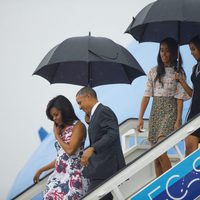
xmin=44 ymin=121 xmax=89 ymax=200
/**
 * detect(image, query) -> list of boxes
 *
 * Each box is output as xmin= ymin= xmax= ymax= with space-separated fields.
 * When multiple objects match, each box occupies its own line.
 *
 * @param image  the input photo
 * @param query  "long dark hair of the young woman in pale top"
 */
xmin=154 ymin=38 xmax=185 ymax=84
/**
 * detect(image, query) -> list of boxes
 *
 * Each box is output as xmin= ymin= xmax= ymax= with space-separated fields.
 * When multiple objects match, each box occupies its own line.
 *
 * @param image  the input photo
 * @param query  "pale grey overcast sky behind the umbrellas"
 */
xmin=0 ymin=0 xmax=159 ymax=200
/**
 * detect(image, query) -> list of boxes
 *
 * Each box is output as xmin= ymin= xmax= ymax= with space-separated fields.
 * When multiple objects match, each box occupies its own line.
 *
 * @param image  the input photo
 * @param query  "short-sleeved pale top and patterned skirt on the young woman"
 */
xmin=144 ymin=67 xmax=190 ymax=144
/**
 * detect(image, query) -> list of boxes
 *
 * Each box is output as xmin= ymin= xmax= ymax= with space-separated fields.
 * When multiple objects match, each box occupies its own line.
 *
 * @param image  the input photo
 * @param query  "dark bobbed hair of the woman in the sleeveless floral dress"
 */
xmin=46 ymin=95 xmax=78 ymax=125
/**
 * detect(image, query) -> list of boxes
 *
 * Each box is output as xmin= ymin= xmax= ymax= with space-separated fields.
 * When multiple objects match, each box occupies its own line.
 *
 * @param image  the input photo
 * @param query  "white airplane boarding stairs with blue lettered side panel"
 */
xmin=13 ymin=115 xmax=200 ymax=200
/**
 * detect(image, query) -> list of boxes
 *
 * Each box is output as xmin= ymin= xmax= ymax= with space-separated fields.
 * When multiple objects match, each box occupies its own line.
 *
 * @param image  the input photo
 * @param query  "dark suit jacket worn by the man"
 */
xmin=83 ymin=104 xmax=125 ymax=180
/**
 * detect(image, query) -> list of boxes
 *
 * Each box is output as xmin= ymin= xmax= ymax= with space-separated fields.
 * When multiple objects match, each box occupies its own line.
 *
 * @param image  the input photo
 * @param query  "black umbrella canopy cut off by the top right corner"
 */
xmin=125 ymin=0 xmax=200 ymax=45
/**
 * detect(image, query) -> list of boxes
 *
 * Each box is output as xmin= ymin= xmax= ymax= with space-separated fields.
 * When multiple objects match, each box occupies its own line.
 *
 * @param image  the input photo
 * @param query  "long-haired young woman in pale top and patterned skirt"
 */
xmin=138 ymin=38 xmax=189 ymax=177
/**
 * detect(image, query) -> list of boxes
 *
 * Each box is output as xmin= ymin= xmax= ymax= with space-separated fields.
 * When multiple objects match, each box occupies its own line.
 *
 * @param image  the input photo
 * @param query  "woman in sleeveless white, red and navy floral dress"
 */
xmin=33 ymin=95 xmax=89 ymax=200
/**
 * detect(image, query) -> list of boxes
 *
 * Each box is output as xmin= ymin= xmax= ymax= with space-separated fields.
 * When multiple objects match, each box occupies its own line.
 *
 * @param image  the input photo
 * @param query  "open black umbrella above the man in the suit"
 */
xmin=33 ymin=35 xmax=145 ymax=87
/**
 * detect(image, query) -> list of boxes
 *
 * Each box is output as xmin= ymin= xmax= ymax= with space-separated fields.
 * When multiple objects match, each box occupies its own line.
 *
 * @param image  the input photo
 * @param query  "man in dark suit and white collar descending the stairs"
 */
xmin=76 ymin=87 xmax=125 ymax=200
